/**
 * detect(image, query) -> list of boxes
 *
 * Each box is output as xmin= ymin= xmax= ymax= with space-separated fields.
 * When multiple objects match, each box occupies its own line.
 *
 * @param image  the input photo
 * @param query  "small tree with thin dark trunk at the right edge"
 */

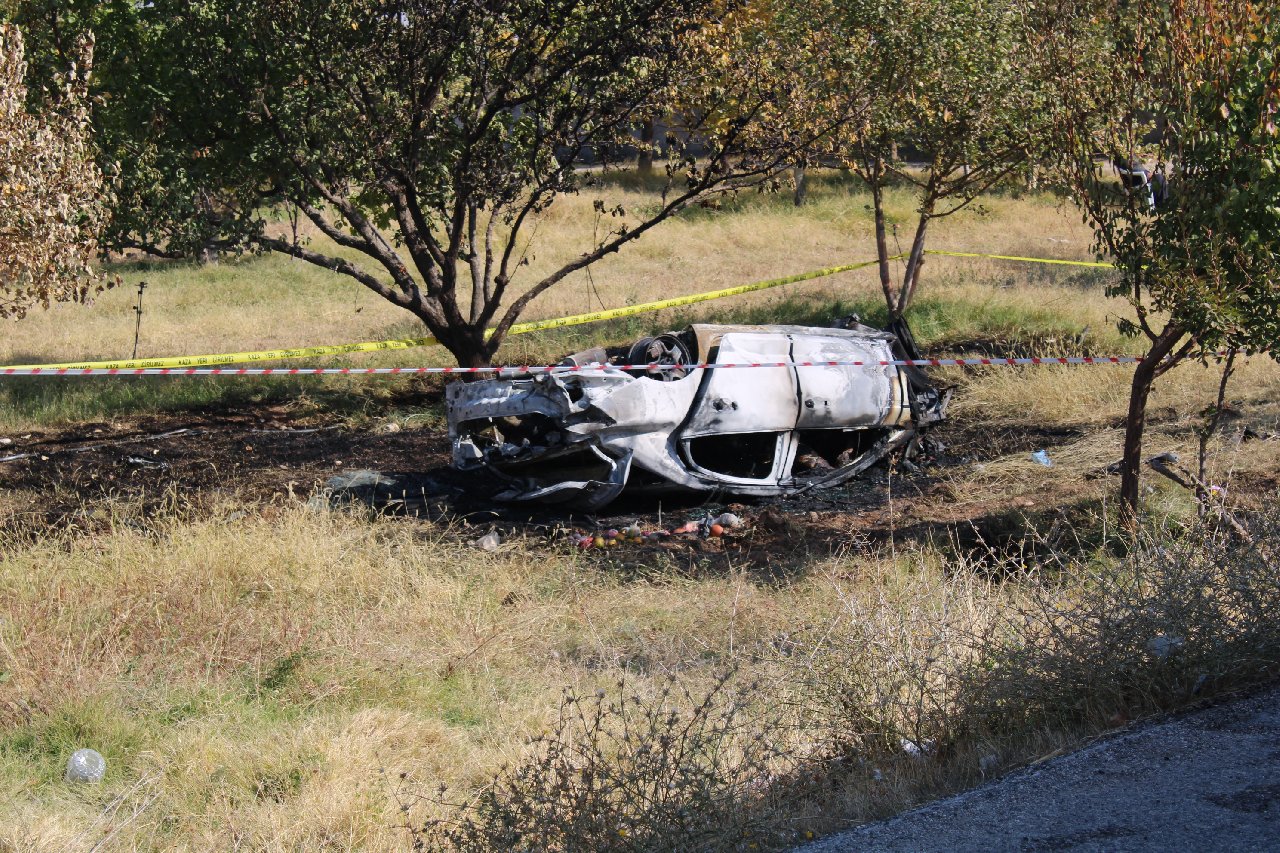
xmin=1055 ymin=0 xmax=1280 ymax=525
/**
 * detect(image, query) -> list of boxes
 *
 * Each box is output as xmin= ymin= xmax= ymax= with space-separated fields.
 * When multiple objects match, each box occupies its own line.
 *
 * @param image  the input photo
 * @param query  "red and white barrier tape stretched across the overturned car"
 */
xmin=0 ymin=356 xmax=1142 ymax=377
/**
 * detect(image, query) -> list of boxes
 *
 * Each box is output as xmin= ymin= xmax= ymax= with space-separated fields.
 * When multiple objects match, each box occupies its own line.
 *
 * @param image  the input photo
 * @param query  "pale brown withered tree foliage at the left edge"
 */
xmin=0 ymin=24 xmax=106 ymax=318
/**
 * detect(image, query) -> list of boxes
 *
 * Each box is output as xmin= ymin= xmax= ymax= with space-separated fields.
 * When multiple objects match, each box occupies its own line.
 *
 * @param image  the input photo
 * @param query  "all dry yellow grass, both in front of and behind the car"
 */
xmin=0 ymin=171 xmax=1280 ymax=850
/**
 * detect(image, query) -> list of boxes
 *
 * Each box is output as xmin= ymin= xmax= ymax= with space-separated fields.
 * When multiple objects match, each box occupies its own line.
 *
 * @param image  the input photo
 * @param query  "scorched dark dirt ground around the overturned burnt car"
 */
xmin=0 ymin=381 xmax=1276 ymax=578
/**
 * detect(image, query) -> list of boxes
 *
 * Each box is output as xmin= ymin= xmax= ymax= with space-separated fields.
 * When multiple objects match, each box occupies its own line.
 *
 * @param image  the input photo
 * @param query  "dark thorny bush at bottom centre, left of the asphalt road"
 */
xmin=404 ymin=675 xmax=819 ymax=852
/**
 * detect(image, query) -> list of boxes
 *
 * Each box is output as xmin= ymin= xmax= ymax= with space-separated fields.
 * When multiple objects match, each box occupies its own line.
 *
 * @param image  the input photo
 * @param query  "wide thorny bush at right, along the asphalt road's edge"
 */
xmin=797 ymin=504 xmax=1280 ymax=761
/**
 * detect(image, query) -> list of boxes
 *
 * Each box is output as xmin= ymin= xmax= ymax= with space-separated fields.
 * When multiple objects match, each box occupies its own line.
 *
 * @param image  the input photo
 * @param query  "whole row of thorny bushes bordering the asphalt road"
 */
xmin=404 ymin=515 xmax=1280 ymax=850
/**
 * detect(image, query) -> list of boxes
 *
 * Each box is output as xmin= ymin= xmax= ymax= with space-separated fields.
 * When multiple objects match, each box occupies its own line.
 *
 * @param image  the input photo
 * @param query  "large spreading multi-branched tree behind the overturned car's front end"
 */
xmin=17 ymin=0 xmax=849 ymax=365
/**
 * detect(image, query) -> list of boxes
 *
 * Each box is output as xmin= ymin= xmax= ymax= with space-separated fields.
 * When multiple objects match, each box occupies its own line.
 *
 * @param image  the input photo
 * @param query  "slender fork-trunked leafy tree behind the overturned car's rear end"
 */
xmin=828 ymin=0 xmax=1053 ymax=319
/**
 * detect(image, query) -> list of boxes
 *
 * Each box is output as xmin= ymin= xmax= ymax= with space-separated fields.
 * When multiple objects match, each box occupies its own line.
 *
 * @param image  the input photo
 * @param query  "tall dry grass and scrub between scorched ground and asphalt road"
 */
xmin=0 ymin=484 xmax=1280 ymax=850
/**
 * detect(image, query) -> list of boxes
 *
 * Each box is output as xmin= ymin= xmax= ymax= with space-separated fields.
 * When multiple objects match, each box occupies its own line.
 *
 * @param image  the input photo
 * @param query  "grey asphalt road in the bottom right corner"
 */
xmin=797 ymin=686 xmax=1280 ymax=853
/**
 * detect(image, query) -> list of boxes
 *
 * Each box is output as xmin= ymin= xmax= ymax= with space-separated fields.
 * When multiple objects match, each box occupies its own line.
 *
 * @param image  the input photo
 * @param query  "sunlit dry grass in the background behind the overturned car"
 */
xmin=0 ymin=177 xmax=1088 ymax=364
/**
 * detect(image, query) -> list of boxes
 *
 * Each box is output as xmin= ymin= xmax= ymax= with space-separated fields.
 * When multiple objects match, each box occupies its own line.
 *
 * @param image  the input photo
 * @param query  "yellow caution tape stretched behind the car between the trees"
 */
xmin=6 ymin=250 xmax=1111 ymax=370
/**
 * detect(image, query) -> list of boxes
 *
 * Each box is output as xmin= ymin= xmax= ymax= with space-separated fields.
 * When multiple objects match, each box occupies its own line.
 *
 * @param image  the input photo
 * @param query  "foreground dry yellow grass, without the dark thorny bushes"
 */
xmin=0 ymin=471 xmax=1270 ymax=850
